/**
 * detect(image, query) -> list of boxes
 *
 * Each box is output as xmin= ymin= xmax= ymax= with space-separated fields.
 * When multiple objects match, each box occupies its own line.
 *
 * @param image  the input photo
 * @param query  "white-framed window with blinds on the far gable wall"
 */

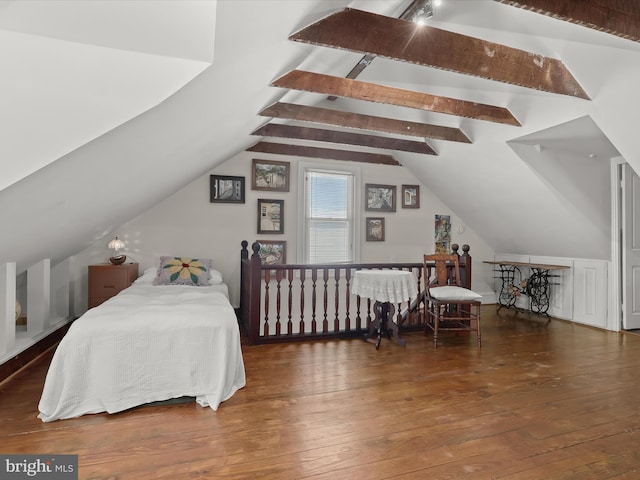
xmin=299 ymin=165 xmax=358 ymax=263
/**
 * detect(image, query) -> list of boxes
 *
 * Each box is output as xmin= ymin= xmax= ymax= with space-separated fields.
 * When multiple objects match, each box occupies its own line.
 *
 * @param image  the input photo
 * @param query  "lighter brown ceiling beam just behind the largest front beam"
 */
xmin=271 ymin=70 xmax=520 ymax=126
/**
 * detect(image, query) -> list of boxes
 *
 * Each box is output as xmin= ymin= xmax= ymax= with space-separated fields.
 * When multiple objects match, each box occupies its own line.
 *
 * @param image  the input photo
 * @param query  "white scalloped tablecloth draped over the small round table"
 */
xmin=351 ymin=270 xmax=418 ymax=303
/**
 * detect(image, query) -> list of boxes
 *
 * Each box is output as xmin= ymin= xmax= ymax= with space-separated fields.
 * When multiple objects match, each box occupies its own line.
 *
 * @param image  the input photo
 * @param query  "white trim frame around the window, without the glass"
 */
xmin=296 ymin=162 xmax=362 ymax=264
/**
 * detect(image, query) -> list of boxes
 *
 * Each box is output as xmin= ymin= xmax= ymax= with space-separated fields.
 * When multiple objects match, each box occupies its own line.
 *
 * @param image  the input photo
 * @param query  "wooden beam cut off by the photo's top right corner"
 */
xmin=495 ymin=0 xmax=640 ymax=42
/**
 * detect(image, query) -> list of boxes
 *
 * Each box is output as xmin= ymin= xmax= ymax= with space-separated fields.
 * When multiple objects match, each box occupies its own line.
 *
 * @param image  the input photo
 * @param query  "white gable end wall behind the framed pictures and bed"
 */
xmin=74 ymin=152 xmax=493 ymax=313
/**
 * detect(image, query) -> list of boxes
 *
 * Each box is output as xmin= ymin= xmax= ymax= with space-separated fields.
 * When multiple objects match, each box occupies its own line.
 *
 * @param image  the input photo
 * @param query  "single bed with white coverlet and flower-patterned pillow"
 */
xmin=38 ymin=257 xmax=245 ymax=422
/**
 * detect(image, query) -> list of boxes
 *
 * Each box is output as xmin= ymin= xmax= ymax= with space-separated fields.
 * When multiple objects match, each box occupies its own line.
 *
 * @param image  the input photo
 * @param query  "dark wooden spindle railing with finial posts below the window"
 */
xmin=239 ymin=240 xmax=471 ymax=345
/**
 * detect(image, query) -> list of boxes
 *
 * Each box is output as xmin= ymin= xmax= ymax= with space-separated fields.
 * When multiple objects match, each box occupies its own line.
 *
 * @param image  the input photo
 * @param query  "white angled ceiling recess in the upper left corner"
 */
xmin=0 ymin=0 xmax=216 ymax=189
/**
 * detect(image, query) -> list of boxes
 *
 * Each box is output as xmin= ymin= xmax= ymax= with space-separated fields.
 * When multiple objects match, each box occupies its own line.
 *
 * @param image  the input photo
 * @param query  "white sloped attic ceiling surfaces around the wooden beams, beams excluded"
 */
xmin=0 ymin=0 xmax=640 ymax=272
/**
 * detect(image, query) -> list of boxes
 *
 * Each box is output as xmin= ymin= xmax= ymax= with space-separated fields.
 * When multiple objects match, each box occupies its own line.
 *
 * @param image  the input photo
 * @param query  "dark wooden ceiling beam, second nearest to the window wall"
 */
xmin=251 ymin=123 xmax=437 ymax=155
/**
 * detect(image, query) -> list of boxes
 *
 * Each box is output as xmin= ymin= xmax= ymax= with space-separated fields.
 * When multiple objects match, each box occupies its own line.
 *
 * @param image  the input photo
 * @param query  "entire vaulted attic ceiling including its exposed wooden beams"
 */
xmin=0 ymin=0 xmax=640 ymax=270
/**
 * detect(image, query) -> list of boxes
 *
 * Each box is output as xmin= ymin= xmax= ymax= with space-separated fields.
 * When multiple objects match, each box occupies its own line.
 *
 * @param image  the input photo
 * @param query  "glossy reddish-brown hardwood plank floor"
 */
xmin=0 ymin=305 xmax=640 ymax=480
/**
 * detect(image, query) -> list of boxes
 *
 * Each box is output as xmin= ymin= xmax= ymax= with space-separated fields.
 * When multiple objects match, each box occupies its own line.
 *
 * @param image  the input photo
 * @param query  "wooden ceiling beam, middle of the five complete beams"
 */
xmin=260 ymin=102 xmax=471 ymax=143
